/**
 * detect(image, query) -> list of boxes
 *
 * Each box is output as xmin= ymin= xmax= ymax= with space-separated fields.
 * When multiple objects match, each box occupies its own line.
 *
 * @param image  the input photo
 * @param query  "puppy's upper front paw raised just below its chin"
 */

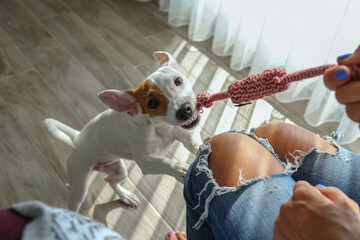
xmin=175 ymin=127 xmax=202 ymax=155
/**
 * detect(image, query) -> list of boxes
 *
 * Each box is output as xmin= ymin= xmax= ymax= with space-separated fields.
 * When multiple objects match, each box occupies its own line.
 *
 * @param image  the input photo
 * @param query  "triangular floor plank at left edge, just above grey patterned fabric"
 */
xmin=0 ymin=109 xmax=67 ymax=208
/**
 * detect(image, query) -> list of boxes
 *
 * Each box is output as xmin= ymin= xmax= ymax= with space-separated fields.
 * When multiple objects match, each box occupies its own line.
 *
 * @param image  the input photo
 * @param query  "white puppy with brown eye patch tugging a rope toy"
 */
xmin=44 ymin=52 xmax=201 ymax=212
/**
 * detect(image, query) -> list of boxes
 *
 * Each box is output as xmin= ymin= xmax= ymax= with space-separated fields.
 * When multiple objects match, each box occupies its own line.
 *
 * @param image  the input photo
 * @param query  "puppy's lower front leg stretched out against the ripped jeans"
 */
xmin=135 ymin=154 xmax=189 ymax=183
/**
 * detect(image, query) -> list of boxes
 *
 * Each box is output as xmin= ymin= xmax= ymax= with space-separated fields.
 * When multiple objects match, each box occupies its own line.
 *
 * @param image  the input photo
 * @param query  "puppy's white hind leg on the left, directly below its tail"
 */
xmin=67 ymin=152 xmax=92 ymax=212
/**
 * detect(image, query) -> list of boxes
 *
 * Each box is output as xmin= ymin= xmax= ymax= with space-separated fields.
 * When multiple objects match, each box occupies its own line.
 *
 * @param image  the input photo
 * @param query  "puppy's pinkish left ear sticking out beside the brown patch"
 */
xmin=99 ymin=90 xmax=141 ymax=116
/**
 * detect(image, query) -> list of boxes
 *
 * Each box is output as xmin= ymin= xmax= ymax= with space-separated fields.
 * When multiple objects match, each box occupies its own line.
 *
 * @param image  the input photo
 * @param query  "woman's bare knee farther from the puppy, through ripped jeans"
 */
xmin=254 ymin=122 xmax=338 ymax=162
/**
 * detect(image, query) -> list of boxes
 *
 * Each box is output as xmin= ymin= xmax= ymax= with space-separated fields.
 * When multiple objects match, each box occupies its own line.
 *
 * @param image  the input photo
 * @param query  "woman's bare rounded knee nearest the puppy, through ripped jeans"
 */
xmin=209 ymin=133 xmax=284 ymax=186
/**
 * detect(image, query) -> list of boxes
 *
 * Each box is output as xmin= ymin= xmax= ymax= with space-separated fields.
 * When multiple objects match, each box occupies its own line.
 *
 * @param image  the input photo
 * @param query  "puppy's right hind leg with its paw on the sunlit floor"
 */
xmin=94 ymin=159 xmax=140 ymax=207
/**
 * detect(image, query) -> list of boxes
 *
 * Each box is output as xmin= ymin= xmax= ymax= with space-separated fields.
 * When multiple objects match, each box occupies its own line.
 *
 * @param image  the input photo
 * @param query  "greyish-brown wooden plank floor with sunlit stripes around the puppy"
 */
xmin=0 ymin=0 xmax=340 ymax=240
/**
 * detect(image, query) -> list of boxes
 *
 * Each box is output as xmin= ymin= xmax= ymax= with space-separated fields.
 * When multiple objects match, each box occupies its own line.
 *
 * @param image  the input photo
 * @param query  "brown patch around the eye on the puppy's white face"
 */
xmin=126 ymin=79 xmax=169 ymax=117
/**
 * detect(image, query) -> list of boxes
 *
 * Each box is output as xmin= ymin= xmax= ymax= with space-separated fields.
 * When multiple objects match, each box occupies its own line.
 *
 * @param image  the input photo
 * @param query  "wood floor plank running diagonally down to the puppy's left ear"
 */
xmin=44 ymin=13 xmax=144 ymax=89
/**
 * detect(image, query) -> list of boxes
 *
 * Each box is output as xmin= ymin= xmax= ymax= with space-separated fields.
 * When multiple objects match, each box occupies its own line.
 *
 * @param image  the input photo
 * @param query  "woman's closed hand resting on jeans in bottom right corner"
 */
xmin=273 ymin=181 xmax=360 ymax=240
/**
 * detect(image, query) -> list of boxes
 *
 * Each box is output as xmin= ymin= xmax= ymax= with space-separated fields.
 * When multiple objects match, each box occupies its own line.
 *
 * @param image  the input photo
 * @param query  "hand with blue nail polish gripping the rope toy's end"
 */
xmin=324 ymin=46 xmax=360 ymax=123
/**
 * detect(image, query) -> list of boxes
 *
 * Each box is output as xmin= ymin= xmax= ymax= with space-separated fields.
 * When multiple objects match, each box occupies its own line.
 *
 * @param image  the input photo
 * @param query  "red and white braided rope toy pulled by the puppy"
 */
xmin=196 ymin=64 xmax=360 ymax=113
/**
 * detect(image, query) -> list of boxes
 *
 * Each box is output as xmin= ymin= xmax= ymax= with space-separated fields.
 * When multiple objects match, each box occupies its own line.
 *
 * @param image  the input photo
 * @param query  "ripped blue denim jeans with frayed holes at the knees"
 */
xmin=184 ymin=132 xmax=360 ymax=240
